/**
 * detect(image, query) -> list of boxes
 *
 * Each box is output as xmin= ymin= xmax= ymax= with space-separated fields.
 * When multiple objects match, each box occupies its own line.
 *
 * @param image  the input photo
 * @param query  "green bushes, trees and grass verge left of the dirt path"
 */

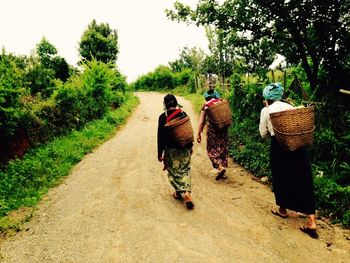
xmin=0 ymin=21 xmax=131 ymax=223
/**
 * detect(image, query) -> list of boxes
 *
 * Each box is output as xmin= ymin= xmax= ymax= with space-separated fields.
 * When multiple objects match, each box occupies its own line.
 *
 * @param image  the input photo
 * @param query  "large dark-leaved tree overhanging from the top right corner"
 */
xmin=167 ymin=0 xmax=350 ymax=95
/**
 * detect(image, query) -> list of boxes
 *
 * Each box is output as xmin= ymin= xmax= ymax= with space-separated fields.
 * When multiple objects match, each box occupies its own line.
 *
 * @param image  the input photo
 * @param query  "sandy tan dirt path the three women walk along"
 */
xmin=0 ymin=93 xmax=350 ymax=263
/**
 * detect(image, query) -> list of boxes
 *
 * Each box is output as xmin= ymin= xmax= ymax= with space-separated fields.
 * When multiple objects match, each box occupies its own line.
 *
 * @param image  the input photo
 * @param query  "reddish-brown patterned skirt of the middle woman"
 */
xmin=207 ymin=121 xmax=229 ymax=168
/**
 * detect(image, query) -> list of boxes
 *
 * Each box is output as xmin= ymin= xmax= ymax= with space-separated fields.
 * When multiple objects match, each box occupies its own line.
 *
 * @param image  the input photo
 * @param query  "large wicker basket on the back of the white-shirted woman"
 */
xmin=270 ymin=106 xmax=315 ymax=151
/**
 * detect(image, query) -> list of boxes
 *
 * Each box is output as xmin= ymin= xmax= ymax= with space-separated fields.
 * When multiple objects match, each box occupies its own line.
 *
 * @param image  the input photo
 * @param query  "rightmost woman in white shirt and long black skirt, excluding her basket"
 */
xmin=259 ymin=83 xmax=318 ymax=238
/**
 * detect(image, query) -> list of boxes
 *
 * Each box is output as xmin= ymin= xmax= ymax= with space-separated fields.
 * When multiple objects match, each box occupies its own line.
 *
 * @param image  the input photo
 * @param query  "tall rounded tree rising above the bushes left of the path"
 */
xmin=79 ymin=20 xmax=119 ymax=63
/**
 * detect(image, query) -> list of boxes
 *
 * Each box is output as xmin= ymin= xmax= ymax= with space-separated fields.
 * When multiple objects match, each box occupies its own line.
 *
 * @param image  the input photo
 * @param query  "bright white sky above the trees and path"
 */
xmin=0 ymin=0 xmax=208 ymax=81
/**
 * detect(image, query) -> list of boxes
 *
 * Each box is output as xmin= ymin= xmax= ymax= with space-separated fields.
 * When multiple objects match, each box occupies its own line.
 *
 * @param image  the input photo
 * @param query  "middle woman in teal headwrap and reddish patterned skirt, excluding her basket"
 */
xmin=197 ymin=89 xmax=228 ymax=180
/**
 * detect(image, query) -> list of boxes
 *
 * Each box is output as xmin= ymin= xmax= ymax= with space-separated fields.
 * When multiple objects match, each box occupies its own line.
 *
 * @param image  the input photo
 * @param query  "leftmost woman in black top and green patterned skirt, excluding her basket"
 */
xmin=157 ymin=94 xmax=194 ymax=209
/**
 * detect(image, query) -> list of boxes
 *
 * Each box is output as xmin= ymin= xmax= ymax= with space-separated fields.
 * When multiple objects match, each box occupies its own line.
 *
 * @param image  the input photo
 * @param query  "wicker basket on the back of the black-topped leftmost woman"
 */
xmin=165 ymin=116 xmax=193 ymax=146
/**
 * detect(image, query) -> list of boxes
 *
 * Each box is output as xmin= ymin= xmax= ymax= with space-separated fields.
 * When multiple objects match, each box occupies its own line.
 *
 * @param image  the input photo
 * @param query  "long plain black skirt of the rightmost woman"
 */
xmin=270 ymin=136 xmax=315 ymax=215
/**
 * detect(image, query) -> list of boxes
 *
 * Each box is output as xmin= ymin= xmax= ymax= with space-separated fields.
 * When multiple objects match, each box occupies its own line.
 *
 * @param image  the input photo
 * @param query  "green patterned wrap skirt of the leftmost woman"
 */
xmin=164 ymin=148 xmax=191 ymax=192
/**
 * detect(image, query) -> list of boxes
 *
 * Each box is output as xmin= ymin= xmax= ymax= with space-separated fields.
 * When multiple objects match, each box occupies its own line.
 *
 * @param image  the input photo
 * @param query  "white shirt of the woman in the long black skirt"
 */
xmin=259 ymin=101 xmax=293 ymax=138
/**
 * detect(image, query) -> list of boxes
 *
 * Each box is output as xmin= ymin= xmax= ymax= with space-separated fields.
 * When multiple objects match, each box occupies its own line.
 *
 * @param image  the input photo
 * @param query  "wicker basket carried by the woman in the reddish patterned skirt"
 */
xmin=205 ymin=99 xmax=232 ymax=129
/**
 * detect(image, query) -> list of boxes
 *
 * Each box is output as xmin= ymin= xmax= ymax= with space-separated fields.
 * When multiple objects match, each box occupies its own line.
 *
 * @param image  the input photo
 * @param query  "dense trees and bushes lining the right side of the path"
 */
xmin=166 ymin=0 xmax=350 ymax=229
